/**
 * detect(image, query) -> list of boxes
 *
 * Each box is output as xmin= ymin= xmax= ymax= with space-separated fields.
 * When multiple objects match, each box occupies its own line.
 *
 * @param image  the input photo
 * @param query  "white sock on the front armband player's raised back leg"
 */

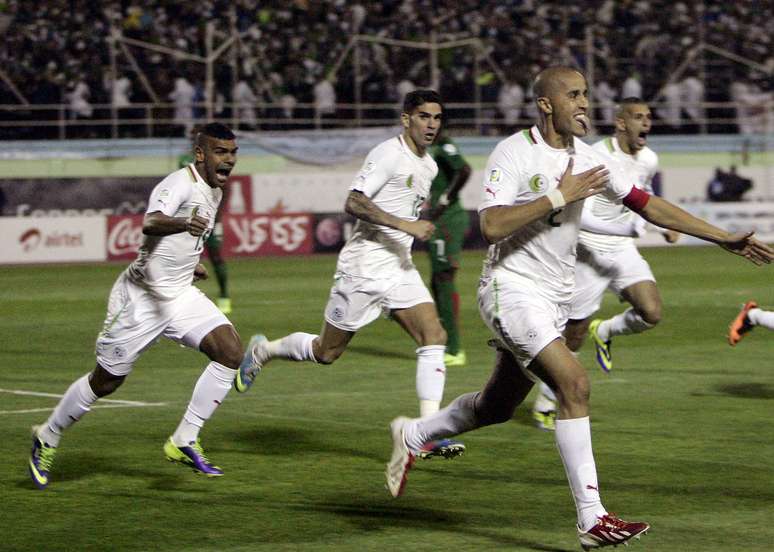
xmin=404 ymin=391 xmax=478 ymax=452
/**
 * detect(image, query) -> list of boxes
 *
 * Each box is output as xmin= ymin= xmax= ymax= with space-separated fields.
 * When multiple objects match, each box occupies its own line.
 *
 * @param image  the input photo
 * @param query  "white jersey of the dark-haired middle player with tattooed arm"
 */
xmin=336 ymin=136 xmax=438 ymax=278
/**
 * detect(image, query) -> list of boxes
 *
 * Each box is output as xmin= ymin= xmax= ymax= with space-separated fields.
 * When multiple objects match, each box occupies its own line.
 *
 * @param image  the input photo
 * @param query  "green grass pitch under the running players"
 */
xmin=0 ymin=248 xmax=774 ymax=552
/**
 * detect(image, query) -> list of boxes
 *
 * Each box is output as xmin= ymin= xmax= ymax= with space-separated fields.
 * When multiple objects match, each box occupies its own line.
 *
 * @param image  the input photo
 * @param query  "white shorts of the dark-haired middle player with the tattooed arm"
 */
xmin=325 ymin=268 xmax=433 ymax=332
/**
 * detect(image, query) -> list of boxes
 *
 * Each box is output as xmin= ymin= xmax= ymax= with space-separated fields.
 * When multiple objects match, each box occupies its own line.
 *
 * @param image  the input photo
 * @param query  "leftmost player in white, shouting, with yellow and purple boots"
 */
xmin=28 ymin=123 xmax=249 ymax=489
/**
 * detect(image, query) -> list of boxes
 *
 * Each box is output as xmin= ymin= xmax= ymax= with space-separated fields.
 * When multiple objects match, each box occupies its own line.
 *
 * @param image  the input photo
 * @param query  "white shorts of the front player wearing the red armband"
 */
xmin=478 ymin=278 xmax=569 ymax=370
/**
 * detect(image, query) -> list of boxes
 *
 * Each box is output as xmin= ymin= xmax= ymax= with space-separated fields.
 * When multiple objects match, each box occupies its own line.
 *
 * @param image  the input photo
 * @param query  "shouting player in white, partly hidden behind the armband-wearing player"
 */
xmin=532 ymin=97 xmax=679 ymax=430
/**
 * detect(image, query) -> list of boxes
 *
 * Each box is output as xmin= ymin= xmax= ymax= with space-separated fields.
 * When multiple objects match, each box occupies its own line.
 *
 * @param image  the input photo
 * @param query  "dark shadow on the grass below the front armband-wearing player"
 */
xmin=287 ymin=496 xmax=575 ymax=552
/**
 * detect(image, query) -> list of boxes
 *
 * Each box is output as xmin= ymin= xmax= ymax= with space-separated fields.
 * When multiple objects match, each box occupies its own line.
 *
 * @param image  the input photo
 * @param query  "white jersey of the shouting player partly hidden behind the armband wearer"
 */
xmin=579 ymin=136 xmax=658 ymax=251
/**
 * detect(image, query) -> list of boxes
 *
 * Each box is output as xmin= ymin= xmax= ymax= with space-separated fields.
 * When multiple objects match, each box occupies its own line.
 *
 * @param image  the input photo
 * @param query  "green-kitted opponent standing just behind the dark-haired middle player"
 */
xmin=429 ymin=134 xmax=471 ymax=366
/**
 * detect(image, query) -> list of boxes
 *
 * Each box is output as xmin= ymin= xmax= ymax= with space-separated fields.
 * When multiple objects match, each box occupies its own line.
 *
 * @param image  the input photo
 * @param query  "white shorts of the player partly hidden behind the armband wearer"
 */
xmin=570 ymin=244 xmax=656 ymax=320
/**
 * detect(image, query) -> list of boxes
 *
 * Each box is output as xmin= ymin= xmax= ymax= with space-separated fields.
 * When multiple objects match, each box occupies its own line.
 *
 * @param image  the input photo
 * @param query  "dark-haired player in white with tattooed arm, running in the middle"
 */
xmin=236 ymin=90 xmax=464 ymax=458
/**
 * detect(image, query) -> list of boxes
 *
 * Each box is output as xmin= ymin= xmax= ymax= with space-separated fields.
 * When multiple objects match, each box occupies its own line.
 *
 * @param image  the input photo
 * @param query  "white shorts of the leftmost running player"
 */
xmin=96 ymin=273 xmax=231 ymax=376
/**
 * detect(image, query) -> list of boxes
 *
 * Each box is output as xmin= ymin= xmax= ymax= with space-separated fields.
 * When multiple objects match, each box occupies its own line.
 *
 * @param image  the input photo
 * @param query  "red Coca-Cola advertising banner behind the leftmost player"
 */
xmin=106 ymin=213 xmax=314 ymax=261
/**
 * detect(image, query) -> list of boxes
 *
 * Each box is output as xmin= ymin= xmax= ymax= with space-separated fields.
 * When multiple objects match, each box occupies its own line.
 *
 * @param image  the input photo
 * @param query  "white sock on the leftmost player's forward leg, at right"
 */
xmin=172 ymin=361 xmax=236 ymax=447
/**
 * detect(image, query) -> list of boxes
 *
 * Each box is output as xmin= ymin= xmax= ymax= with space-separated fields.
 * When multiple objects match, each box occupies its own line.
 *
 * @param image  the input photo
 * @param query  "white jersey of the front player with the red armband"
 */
xmin=478 ymin=126 xmax=632 ymax=303
